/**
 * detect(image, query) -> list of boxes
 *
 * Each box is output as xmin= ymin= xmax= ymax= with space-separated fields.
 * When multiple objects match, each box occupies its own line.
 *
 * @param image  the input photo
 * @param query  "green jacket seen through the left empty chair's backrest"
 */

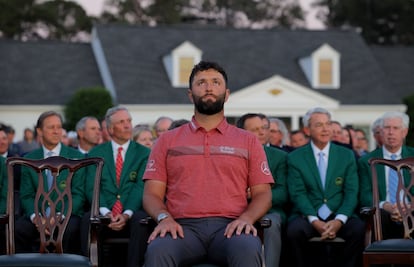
xmin=20 ymin=144 xmax=86 ymax=219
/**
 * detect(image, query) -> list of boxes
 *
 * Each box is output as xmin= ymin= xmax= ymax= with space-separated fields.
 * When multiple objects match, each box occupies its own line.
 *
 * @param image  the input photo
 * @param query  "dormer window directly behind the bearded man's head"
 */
xmin=163 ymin=41 xmax=202 ymax=87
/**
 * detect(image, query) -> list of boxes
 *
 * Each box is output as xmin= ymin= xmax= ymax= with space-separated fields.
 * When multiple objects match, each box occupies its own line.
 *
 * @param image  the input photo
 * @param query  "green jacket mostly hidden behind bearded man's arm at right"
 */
xmin=264 ymin=146 xmax=288 ymax=223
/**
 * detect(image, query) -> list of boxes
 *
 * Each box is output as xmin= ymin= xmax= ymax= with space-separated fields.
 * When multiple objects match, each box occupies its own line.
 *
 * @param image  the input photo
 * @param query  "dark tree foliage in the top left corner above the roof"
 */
xmin=0 ymin=0 xmax=92 ymax=41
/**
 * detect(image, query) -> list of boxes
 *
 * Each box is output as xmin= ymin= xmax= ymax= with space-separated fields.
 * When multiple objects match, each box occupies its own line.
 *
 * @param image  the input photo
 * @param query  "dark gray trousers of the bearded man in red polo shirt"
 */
xmin=144 ymin=217 xmax=262 ymax=267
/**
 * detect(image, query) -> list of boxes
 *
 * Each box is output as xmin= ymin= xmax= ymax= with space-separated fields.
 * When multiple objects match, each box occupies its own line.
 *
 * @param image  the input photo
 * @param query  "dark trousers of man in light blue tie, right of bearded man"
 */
xmin=287 ymin=217 xmax=365 ymax=267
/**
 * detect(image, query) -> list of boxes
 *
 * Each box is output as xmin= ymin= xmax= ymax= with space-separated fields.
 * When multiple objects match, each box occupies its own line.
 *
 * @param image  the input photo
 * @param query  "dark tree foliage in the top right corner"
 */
xmin=317 ymin=0 xmax=414 ymax=45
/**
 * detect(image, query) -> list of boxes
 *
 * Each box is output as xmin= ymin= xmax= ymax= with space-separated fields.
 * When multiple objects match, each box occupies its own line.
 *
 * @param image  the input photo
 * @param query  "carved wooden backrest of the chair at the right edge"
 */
xmin=369 ymin=157 xmax=414 ymax=240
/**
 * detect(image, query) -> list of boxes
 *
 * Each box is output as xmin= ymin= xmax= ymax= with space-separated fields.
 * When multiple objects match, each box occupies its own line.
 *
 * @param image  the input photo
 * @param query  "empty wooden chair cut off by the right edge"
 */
xmin=363 ymin=157 xmax=414 ymax=267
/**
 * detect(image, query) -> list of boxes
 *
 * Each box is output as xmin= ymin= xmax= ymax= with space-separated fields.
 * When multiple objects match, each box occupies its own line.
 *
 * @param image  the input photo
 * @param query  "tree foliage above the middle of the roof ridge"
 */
xmin=100 ymin=0 xmax=304 ymax=29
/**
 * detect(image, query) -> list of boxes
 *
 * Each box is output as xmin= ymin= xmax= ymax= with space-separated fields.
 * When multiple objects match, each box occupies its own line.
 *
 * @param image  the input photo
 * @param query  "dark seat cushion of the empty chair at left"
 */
xmin=0 ymin=253 xmax=92 ymax=267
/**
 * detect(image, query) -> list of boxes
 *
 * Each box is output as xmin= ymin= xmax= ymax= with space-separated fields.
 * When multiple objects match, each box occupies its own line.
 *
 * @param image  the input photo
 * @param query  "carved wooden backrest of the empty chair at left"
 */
xmin=6 ymin=156 xmax=103 ymax=254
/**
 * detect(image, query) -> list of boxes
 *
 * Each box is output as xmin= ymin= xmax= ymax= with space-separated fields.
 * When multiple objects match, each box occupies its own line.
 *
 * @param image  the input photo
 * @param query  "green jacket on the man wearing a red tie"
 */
xmin=85 ymin=141 xmax=150 ymax=214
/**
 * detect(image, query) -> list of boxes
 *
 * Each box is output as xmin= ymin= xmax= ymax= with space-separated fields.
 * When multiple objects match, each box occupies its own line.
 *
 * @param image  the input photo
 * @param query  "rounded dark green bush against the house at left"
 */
xmin=64 ymin=87 xmax=113 ymax=130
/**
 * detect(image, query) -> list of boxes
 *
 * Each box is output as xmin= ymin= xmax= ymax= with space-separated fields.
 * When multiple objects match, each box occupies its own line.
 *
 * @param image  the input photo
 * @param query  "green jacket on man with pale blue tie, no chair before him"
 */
xmin=288 ymin=143 xmax=358 ymax=221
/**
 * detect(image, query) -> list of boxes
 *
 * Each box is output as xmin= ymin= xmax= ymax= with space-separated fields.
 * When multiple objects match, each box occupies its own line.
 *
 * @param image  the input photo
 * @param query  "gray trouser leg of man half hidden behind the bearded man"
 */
xmin=263 ymin=212 xmax=282 ymax=267
